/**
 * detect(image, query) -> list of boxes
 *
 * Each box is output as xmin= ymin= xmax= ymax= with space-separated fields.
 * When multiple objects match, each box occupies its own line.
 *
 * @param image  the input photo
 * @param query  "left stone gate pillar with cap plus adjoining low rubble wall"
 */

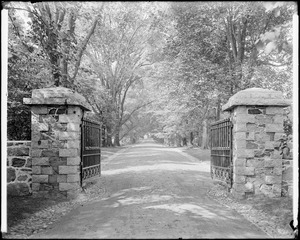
xmin=7 ymin=87 xmax=91 ymax=198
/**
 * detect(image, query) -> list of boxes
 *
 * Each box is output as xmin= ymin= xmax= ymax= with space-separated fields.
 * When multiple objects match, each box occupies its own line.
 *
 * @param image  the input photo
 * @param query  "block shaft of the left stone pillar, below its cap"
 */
xmin=31 ymin=106 xmax=83 ymax=197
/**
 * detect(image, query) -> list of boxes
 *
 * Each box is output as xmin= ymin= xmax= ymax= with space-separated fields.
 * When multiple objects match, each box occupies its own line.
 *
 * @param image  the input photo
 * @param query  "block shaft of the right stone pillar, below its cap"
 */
xmin=232 ymin=106 xmax=284 ymax=197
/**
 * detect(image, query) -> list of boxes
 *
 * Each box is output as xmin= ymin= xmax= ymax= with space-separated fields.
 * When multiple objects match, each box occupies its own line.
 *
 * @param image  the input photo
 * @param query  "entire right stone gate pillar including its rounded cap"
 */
xmin=222 ymin=88 xmax=290 ymax=198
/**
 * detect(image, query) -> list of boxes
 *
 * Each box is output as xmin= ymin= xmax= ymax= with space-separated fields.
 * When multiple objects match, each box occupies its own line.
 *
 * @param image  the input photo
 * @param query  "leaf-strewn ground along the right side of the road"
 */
xmin=183 ymin=148 xmax=293 ymax=238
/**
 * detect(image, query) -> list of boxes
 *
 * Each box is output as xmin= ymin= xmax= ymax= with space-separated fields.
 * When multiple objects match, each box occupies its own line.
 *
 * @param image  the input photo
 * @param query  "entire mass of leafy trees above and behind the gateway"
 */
xmin=6 ymin=2 xmax=296 ymax=148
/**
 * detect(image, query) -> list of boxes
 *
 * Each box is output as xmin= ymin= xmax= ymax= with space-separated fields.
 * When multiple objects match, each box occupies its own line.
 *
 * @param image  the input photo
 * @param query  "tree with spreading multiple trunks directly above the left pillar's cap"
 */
xmin=22 ymin=2 xmax=104 ymax=88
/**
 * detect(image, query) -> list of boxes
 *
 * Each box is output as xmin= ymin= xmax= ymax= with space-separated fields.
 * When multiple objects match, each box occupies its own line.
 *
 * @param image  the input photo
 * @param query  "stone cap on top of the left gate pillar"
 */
xmin=23 ymin=87 xmax=92 ymax=111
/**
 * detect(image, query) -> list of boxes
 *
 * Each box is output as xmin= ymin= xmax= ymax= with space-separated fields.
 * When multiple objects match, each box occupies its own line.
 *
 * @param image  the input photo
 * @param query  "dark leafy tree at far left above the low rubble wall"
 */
xmin=7 ymin=4 xmax=52 ymax=140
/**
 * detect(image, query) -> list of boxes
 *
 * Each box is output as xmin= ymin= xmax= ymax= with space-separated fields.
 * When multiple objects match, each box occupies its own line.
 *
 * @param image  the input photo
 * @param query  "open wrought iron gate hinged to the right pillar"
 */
xmin=210 ymin=118 xmax=232 ymax=188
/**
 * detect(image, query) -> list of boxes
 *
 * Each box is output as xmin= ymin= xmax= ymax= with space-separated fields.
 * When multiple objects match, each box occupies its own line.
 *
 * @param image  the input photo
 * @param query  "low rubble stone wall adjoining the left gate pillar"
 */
xmin=7 ymin=141 xmax=32 ymax=196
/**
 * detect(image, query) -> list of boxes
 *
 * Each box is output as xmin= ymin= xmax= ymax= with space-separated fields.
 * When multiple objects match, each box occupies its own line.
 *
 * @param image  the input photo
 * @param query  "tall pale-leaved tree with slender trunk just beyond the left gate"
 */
xmin=83 ymin=3 xmax=165 ymax=145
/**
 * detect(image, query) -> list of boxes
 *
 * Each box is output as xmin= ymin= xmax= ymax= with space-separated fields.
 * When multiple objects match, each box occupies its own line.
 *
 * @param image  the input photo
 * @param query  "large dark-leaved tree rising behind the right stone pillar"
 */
xmin=151 ymin=2 xmax=295 ymax=146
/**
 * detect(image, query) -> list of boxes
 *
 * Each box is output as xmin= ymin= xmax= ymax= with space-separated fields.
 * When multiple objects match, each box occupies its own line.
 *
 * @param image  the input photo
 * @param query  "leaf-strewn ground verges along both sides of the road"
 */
xmin=7 ymin=144 xmax=293 ymax=238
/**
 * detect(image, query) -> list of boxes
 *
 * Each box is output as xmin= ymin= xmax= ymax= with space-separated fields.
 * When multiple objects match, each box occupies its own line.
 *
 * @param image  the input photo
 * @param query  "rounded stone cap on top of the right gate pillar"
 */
xmin=222 ymin=88 xmax=291 ymax=111
